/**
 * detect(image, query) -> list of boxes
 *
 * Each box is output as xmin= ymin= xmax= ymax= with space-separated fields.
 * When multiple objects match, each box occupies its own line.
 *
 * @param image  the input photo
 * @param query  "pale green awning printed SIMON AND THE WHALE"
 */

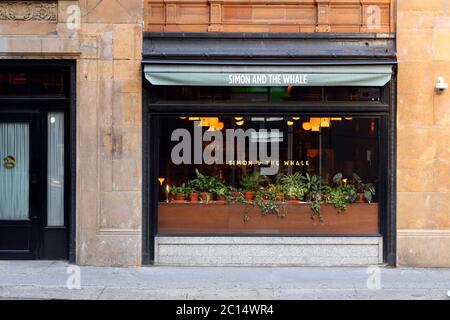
xmin=144 ymin=64 xmax=392 ymax=87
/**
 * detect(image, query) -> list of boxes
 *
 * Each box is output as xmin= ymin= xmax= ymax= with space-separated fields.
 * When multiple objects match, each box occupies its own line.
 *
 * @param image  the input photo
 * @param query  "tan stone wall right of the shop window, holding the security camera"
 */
xmin=397 ymin=0 xmax=450 ymax=267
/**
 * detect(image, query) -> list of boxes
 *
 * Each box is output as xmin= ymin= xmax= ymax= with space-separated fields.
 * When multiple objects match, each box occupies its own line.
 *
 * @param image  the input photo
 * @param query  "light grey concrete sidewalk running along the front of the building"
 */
xmin=0 ymin=261 xmax=450 ymax=299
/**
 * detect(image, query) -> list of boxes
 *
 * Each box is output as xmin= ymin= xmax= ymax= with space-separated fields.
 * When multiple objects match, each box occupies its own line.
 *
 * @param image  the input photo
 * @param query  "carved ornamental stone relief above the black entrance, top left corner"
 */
xmin=0 ymin=1 xmax=58 ymax=22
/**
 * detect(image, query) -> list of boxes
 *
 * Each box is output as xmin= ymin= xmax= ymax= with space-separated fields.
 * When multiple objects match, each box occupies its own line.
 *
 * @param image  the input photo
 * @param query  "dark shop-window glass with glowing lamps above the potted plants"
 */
xmin=158 ymin=115 xmax=379 ymax=201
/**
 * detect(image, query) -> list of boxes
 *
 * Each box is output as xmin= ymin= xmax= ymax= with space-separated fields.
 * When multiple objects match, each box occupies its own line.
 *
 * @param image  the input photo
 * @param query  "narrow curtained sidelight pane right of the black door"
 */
xmin=47 ymin=112 xmax=64 ymax=227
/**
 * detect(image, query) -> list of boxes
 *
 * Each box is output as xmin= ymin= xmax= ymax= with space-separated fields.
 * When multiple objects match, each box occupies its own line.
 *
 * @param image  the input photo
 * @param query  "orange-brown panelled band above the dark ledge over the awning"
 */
xmin=144 ymin=0 xmax=394 ymax=32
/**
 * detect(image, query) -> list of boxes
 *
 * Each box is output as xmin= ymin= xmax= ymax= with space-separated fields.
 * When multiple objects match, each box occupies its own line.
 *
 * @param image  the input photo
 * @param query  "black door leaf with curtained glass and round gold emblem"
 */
xmin=0 ymin=112 xmax=43 ymax=259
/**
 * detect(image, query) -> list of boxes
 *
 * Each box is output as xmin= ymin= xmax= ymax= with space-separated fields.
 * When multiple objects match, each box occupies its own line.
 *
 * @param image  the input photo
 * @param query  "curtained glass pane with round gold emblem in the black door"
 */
xmin=0 ymin=123 xmax=30 ymax=220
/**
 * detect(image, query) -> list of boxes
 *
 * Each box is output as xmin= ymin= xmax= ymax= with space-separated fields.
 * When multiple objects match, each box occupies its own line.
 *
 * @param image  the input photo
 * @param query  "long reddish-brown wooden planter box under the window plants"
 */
xmin=158 ymin=202 xmax=379 ymax=235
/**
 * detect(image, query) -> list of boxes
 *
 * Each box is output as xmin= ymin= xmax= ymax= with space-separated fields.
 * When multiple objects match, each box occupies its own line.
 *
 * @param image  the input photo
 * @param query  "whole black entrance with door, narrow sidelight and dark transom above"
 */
xmin=0 ymin=59 xmax=76 ymax=261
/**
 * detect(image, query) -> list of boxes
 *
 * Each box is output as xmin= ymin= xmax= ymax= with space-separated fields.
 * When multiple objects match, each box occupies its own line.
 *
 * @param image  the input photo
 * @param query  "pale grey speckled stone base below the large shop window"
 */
xmin=155 ymin=236 xmax=383 ymax=266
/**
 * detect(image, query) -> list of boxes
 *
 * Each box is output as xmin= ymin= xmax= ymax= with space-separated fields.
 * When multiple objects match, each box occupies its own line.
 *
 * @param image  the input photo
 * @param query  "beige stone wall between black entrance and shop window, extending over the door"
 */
xmin=0 ymin=0 xmax=143 ymax=266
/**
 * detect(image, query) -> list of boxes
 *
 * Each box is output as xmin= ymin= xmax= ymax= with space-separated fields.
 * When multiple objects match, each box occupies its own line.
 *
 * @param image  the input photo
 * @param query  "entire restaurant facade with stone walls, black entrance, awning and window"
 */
xmin=0 ymin=0 xmax=450 ymax=267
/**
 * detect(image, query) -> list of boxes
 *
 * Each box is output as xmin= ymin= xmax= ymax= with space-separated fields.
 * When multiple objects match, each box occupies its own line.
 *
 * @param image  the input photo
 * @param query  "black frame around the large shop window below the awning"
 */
xmin=142 ymin=69 xmax=397 ymax=266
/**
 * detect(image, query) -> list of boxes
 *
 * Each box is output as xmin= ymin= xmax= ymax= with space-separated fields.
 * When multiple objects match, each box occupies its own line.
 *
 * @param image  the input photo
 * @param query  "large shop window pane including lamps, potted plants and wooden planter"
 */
xmin=155 ymin=114 xmax=380 ymax=234
